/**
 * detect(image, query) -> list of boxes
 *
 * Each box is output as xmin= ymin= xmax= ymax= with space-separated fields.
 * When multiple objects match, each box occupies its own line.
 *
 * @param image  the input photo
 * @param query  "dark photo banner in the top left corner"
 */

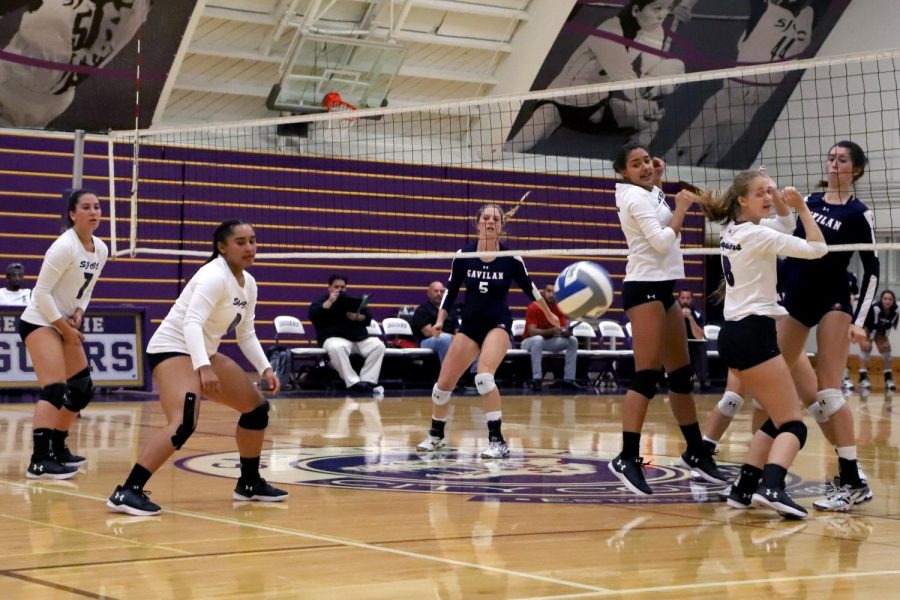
xmin=0 ymin=0 xmax=196 ymax=131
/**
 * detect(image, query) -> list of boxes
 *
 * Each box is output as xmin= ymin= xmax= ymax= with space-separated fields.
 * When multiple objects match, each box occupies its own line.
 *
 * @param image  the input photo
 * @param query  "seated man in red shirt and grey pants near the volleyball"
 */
xmin=522 ymin=284 xmax=581 ymax=392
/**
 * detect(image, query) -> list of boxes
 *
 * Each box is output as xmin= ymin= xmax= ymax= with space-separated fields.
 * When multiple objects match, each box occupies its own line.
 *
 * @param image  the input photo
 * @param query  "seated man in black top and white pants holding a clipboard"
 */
xmin=309 ymin=275 xmax=384 ymax=394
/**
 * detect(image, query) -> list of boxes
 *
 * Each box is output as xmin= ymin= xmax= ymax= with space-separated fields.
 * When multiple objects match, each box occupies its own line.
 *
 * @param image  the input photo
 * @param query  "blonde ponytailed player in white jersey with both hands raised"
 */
xmin=698 ymin=171 xmax=828 ymax=518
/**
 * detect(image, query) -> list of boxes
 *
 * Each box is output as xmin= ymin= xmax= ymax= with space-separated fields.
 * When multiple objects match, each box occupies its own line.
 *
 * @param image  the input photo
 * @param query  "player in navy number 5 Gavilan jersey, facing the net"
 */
xmin=417 ymin=204 xmax=559 ymax=459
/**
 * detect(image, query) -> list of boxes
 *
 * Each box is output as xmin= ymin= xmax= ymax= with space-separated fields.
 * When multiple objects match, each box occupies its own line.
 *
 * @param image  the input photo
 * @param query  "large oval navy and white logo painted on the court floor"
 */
xmin=176 ymin=447 xmax=825 ymax=504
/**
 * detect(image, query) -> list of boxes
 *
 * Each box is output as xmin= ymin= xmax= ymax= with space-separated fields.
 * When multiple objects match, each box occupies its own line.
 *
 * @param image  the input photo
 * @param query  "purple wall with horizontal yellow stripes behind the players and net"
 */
xmin=0 ymin=134 xmax=703 ymax=366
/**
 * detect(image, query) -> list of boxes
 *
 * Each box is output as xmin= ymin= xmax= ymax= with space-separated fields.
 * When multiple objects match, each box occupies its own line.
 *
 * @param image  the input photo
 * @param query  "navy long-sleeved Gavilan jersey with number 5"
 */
xmin=441 ymin=243 xmax=541 ymax=324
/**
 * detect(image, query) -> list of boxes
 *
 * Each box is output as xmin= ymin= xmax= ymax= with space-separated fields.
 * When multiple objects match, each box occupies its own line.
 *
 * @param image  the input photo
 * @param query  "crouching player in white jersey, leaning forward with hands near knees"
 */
xmin=106 ymin=221 xmax=288 ymax=516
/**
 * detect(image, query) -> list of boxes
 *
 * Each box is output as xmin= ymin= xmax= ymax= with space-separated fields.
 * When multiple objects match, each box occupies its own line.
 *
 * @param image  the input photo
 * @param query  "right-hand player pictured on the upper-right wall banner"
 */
xmin=666 ymin=0 xmax=814 ymax=167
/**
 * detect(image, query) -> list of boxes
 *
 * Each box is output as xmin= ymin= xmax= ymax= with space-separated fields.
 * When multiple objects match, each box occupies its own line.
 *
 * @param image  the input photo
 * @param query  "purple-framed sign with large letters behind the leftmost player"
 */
xmin=0 ymin=307 xmax=147 ymax=388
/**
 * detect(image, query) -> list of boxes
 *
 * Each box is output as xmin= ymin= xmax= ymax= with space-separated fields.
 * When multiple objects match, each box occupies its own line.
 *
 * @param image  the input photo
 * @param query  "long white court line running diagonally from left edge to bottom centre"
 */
xmin=0 ymin=479 xmax=616 ymax=597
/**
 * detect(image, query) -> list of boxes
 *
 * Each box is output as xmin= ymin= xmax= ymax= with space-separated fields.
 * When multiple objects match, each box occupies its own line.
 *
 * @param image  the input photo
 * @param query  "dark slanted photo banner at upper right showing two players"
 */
xmin=506 ymin=0 xmax=851 ymax=169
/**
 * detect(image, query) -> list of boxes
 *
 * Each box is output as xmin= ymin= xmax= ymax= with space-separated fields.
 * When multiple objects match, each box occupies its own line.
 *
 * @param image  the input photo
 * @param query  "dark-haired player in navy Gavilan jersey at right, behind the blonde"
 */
xmin=778 ymin=140 xmax=879 ymax=511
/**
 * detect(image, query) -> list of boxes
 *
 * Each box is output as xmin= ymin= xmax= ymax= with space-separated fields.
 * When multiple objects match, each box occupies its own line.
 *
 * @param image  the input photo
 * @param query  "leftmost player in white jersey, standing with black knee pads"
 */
xmin=19 ymin=190 xmax=109 ymax=479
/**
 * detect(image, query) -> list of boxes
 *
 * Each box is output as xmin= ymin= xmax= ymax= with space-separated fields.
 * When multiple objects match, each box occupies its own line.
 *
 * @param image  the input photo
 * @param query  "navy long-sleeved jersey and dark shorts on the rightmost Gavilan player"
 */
xmin=780 ymin=192 xmax=879 ymax=327
